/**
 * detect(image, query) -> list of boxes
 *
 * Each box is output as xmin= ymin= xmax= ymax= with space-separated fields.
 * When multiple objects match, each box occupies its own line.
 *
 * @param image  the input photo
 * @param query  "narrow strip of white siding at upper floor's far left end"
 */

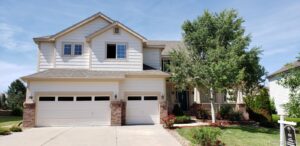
xmin=39 ymin=43 xmax=54 ymax=71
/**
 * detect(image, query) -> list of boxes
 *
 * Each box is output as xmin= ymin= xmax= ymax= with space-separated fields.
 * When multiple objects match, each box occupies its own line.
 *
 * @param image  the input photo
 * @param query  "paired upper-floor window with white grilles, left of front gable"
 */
xmin=63 ymin=43 xmax=83 ymax=56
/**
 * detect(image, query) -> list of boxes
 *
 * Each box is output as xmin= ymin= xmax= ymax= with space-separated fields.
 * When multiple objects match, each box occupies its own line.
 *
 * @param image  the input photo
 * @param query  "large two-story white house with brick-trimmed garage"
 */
xmin=22 ymin=13 xmax=242 ymax=127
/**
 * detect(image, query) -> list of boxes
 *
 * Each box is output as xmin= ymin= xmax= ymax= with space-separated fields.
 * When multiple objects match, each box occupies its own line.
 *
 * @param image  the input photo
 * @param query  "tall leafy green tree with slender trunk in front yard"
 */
xmin=169 ymin=10 xmax=265 ymax=121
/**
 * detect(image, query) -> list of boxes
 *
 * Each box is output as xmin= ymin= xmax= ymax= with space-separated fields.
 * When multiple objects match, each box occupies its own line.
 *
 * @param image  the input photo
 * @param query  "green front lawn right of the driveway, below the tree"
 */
xmin=177 ymin=126 xmax=300 ymax=146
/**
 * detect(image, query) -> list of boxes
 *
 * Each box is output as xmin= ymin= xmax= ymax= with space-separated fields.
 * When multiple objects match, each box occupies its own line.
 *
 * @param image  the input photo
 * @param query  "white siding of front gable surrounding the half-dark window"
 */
xmin=91 ymin=29 xmax=143 ymax=71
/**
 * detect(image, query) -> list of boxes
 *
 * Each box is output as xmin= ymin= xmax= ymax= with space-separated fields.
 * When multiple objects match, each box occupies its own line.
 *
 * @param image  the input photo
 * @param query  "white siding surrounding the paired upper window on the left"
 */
xmin=55 ymin=18 xmax=108 ymax=69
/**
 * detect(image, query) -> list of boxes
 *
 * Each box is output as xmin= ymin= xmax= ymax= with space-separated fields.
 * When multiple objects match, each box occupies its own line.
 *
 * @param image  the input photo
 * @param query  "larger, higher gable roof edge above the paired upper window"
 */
xmin=33 ymin=12 xmax=115 ymax=43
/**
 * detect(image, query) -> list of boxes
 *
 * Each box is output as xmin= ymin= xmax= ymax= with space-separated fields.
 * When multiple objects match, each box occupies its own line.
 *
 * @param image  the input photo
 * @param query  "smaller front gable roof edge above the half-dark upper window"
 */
xmin=86 ymin=21 xmax=147 ymax=42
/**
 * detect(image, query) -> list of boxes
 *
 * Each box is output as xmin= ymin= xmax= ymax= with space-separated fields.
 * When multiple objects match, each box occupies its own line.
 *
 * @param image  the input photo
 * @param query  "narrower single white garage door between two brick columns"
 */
xmin=126 ymin=96 xmax=159 ymax=124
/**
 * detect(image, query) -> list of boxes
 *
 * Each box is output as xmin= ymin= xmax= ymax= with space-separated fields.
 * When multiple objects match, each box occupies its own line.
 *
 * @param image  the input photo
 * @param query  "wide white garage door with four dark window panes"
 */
xmin=36 ymin=96 xmax=111 ymax=126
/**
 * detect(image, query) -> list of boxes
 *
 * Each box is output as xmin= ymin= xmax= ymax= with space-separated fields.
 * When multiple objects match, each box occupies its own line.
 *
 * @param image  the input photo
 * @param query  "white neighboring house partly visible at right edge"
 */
xmin=268 ymin=60 xmax=300 ymax=115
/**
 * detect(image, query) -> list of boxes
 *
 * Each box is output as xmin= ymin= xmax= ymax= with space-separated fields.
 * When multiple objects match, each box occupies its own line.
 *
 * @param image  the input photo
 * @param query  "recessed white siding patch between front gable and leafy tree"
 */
xmin=143 ymin=48 xmax=161 ymax=70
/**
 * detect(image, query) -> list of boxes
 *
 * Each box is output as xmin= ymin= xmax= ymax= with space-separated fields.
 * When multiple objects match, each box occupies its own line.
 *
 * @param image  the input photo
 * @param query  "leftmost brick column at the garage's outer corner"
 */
xmin=23 ymin=102 xmax=35 ymax=127
